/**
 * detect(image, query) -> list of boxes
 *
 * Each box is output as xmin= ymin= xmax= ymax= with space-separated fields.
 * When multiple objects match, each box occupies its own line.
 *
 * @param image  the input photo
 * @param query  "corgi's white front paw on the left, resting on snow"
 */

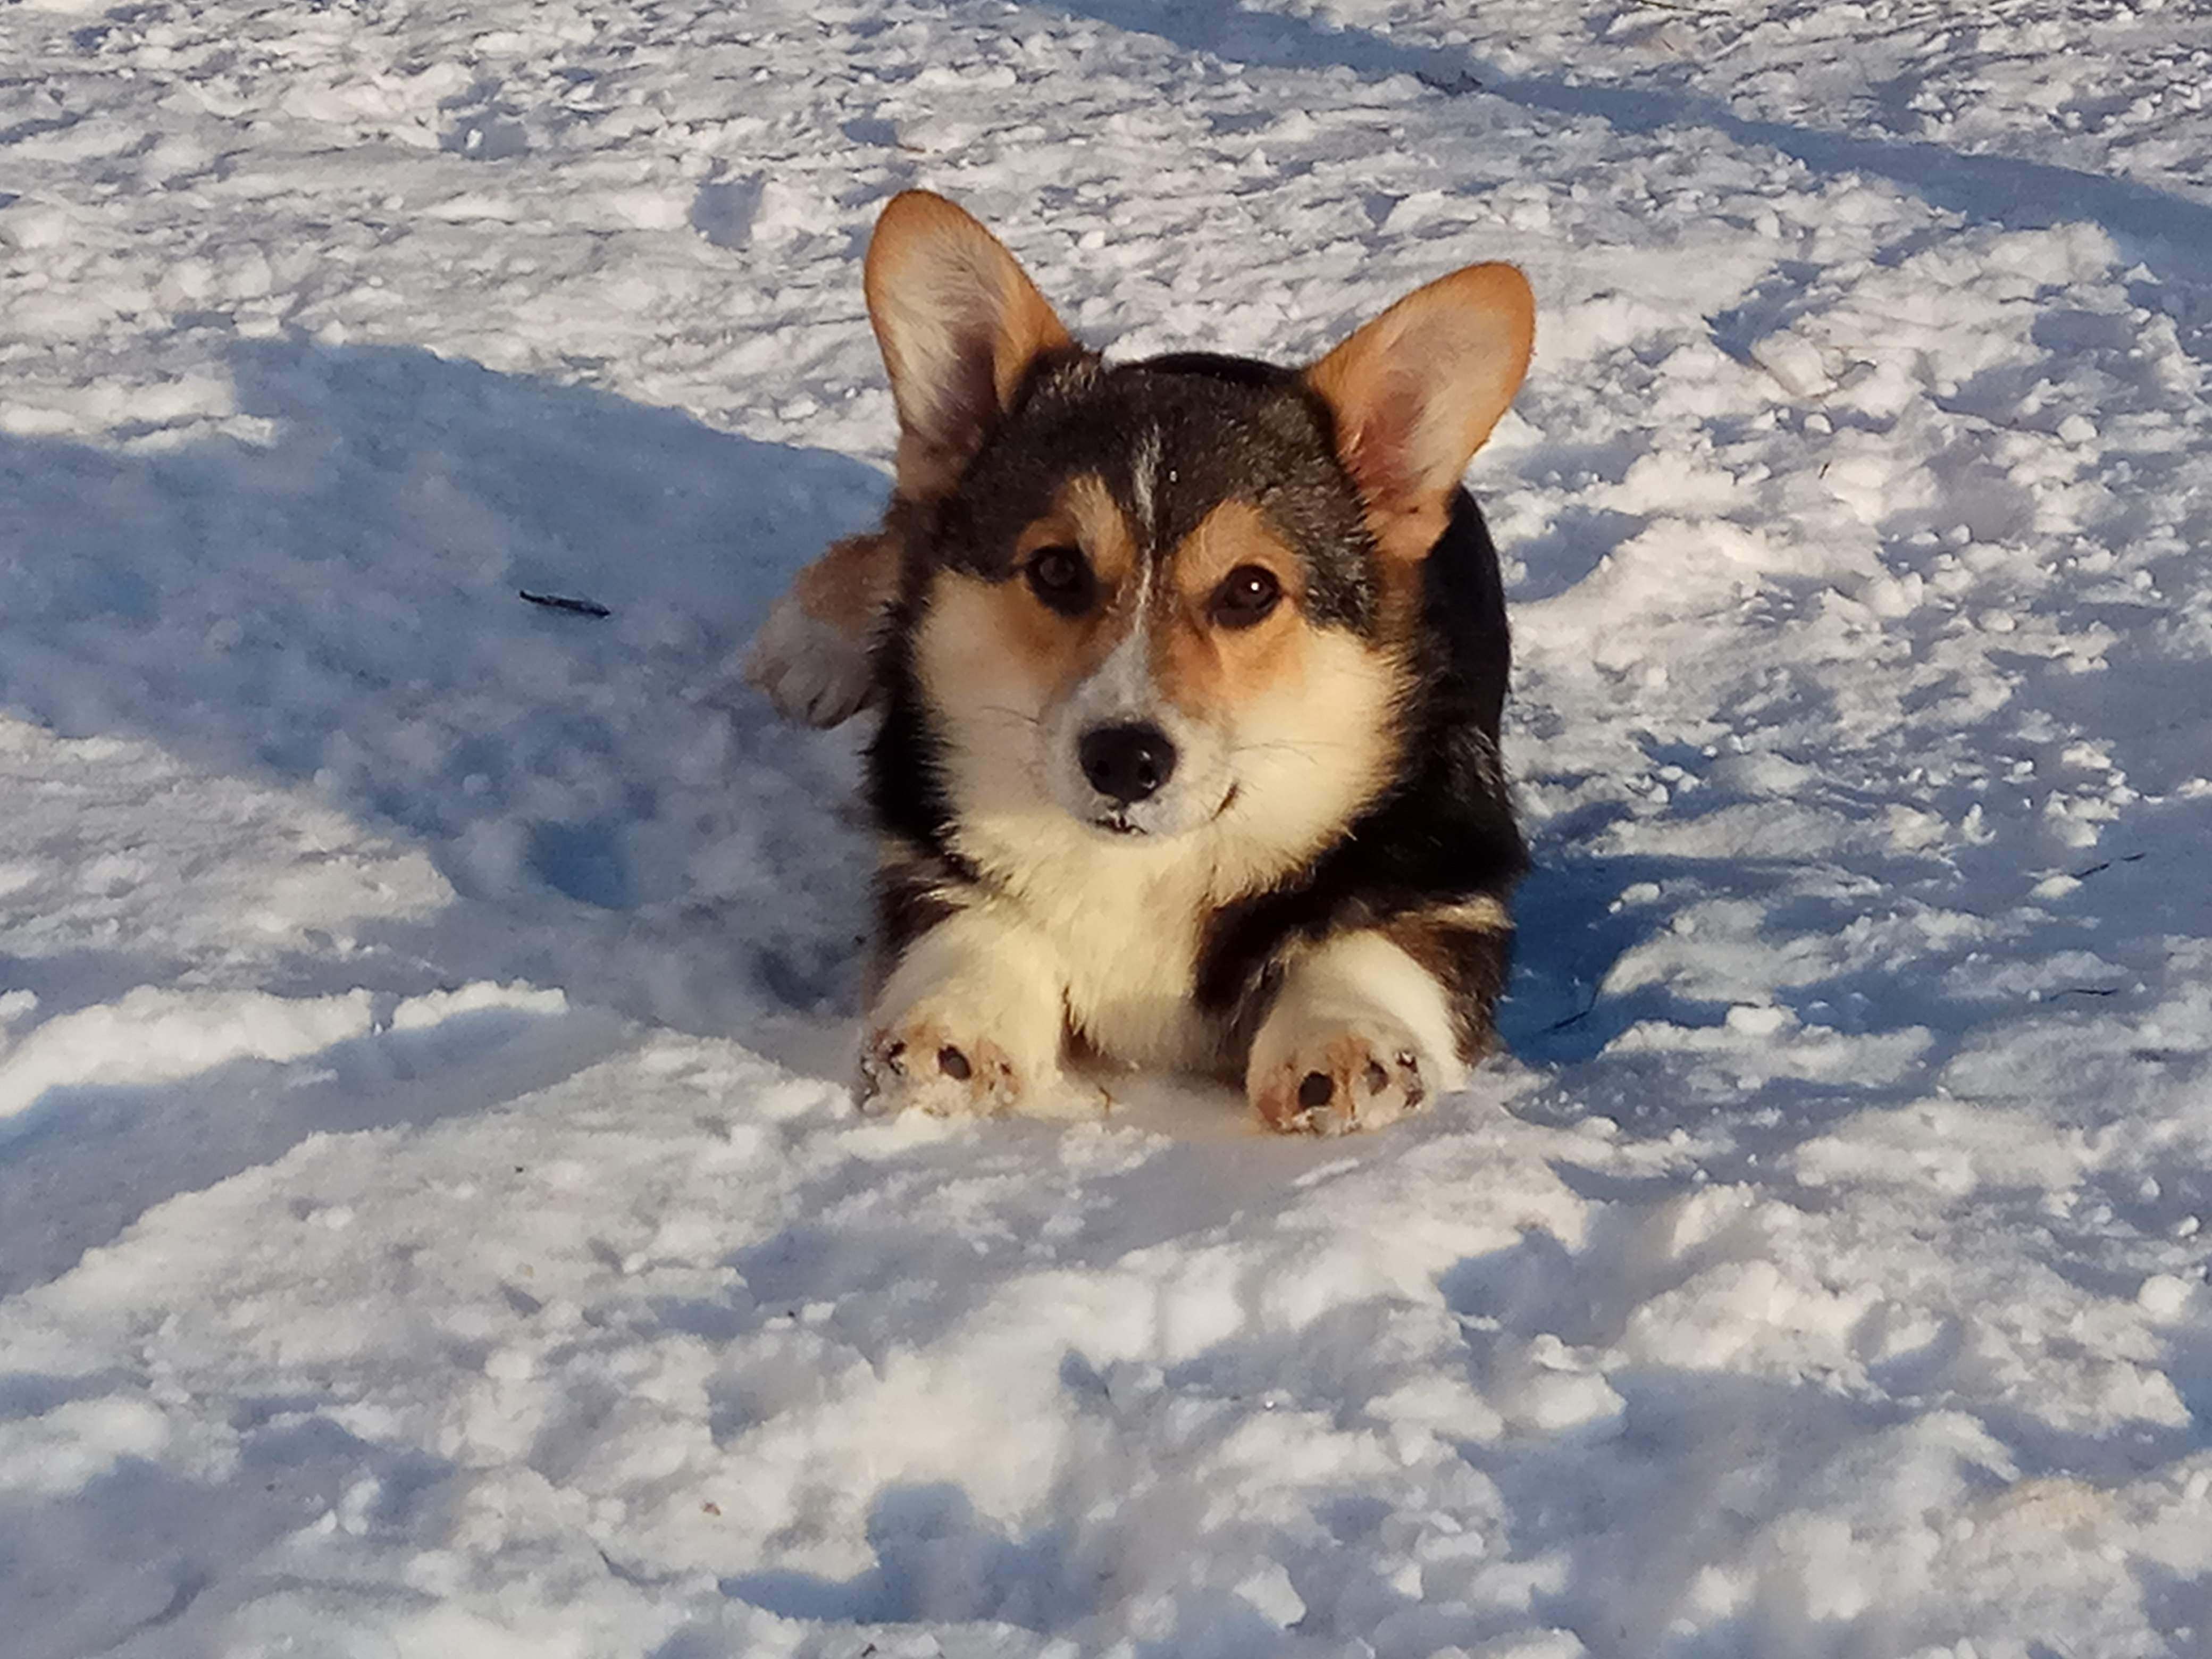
xmin=856 ymin=907 xmax=1066 ymax=1117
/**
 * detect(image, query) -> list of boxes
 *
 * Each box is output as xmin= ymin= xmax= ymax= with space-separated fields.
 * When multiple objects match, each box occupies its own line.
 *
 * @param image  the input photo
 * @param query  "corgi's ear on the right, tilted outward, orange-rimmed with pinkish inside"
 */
xmin=1305 ymin=265 xmax=1535 ymax=557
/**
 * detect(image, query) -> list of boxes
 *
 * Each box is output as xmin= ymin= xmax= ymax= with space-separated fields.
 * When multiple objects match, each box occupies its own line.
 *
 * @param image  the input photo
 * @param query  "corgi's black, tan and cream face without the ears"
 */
xmin=914 ymin=358 xmax=1405 ymax=872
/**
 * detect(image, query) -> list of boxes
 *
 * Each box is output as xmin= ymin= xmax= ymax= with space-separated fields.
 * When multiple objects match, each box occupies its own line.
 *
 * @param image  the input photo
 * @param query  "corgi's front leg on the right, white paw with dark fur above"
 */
xmin=1245 ymin=898 xmax=1511 ymax=1135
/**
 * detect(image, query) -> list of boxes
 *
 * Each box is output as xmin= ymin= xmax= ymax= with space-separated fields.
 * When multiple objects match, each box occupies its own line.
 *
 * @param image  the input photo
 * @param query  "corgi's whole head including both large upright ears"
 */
xmin=867 ymin=192 xmax=1533 ymax=891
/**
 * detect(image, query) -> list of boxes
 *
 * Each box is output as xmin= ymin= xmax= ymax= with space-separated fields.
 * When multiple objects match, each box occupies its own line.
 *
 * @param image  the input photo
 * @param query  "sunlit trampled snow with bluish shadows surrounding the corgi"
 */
xmin=0 ymin=0 xmax=2212 ymax=1659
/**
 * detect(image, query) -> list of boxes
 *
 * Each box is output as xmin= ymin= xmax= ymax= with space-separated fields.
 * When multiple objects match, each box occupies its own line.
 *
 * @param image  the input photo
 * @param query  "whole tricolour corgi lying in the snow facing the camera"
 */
xmin=748 ymin=190 xmax=1535 ymax=1135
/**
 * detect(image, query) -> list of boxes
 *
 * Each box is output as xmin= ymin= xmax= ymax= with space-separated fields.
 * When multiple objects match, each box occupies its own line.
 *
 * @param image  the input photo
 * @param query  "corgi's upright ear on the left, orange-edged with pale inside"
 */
xmin=865 ymin=190 xmax=1073 ymax=500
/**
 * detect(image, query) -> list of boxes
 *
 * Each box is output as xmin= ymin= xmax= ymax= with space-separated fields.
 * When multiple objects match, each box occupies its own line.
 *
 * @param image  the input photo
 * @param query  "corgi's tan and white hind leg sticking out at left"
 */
xmin=745 ymin=526 xmax=900 ymax=725
